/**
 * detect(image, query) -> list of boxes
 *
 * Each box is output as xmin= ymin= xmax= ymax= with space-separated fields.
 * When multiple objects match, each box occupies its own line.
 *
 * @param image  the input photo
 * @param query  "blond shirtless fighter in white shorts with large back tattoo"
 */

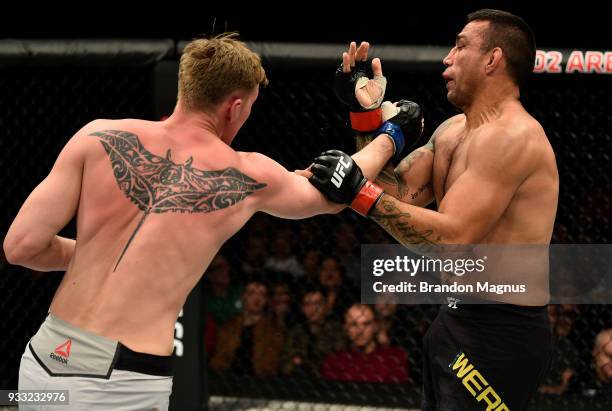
xmin=4 ymin=35 xmax=416 ymax=410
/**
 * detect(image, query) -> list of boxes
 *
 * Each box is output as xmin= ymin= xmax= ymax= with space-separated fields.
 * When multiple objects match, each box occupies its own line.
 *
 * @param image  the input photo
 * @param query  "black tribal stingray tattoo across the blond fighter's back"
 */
xmin=90 ymin=130 xmax=266 ymax=271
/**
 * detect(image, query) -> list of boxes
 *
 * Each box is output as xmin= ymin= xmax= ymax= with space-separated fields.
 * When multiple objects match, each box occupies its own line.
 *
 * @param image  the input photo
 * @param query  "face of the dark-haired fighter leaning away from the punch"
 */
xmin=442 ymin=21 xmax=489 ymax=108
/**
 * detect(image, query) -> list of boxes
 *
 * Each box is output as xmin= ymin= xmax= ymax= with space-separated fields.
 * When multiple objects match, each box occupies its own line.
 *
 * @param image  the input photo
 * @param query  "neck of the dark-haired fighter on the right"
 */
xmin=463 ymin=83 xmax=520 ymax=129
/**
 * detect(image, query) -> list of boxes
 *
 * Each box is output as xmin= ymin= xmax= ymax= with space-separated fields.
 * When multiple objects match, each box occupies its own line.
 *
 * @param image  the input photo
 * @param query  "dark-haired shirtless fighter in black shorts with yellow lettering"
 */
xmin=310 ymin=9 xmax=559 ymax=411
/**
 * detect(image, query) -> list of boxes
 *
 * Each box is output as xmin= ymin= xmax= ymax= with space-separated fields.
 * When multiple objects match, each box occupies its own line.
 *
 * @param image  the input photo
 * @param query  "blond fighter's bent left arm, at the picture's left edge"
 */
xmin=4 ymin=124 xmax=93 ymax=271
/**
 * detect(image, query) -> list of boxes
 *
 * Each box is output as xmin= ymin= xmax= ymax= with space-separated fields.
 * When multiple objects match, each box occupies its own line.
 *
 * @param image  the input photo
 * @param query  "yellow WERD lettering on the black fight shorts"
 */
xmin=449 ymin=352 xmax=509 ymax=411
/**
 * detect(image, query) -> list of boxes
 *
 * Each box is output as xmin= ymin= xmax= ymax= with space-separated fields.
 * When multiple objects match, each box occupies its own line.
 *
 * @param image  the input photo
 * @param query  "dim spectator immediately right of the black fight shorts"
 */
xmin=539 ymin=304 xmax=580 ymax=395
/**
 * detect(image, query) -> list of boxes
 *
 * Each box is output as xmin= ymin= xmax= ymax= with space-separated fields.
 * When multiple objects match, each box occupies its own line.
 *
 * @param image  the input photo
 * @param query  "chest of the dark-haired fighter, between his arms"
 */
xmin=433 ymin=130 xmax=474 ymax=204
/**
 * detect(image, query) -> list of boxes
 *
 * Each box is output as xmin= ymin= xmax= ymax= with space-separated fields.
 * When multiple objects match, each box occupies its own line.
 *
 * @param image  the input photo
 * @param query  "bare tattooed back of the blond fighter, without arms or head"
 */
xmin=50 ymin=120 xmax=262 ymax=355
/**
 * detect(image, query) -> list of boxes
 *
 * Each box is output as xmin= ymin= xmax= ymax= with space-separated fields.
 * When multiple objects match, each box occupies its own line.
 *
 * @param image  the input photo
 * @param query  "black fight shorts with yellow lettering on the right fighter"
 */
xmin=422 ymin=304 xmax=553 ymax=411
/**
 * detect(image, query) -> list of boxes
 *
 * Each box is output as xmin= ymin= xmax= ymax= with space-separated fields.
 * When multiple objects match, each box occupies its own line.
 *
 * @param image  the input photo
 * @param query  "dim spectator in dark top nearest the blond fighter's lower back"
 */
xmin=204 ymin=254 xmax=242 ymax=326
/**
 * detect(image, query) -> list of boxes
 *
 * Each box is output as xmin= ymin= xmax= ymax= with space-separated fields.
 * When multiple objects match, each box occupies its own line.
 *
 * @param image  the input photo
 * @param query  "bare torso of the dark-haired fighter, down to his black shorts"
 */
xmin=433 ymin=107 xmax=559 ymax=305
